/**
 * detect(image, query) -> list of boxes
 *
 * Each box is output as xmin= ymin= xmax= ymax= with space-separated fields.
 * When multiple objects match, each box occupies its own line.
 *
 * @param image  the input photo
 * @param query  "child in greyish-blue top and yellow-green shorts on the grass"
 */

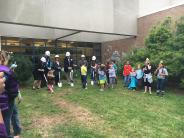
xmin=98 ymin=64 xmax=106 ymax=91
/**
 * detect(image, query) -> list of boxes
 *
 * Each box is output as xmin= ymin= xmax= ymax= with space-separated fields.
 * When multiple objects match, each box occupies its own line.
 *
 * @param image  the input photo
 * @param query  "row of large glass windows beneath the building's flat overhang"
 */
xmin=1 ymin=37 xmax=101 ymax=64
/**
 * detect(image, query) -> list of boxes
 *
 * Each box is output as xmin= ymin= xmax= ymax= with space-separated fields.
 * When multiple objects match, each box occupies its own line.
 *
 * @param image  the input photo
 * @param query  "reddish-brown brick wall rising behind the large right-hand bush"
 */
xmin=101 ymin=5 xmax=184 ymax=62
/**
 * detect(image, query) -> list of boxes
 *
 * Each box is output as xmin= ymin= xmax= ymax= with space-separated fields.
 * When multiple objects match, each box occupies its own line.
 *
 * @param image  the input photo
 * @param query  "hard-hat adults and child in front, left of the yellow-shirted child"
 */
xmin=33 ymin=51 xmax=74 ymax=93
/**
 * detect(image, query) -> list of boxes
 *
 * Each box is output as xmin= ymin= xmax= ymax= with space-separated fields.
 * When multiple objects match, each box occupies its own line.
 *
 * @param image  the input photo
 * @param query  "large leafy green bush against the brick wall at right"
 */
xmin=122 ymin=17 xmax=184 ymax=88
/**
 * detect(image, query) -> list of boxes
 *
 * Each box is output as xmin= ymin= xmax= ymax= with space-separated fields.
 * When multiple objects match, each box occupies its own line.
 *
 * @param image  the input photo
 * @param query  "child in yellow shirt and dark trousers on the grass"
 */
xmin=81 ymin=62 xmax=87 ymax=89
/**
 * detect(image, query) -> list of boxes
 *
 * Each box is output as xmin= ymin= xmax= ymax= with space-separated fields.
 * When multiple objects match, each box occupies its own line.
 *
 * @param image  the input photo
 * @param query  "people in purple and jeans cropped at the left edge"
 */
xmin=0 ymin=51 xmax=22 ymax=138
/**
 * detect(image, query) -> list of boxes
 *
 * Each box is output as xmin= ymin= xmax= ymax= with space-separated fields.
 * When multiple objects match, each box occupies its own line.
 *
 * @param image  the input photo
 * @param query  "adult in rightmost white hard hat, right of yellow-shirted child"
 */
xmin=90 ymin=56 xmax=98 ymax=85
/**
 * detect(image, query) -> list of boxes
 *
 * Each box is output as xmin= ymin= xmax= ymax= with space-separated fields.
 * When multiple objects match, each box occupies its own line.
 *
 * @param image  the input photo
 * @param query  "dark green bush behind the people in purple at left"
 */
xmin=10 ymin=55 xmax=32 ymax=85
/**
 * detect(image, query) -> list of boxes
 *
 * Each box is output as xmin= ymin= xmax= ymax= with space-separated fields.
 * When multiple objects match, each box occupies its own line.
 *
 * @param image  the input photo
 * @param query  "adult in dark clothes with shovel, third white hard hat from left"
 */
xmin=53 ymin=55 xmax=62 ymax=87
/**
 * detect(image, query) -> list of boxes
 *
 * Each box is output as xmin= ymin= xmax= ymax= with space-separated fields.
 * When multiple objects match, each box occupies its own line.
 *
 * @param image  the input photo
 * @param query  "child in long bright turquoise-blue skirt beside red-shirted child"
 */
xmin=128 ymin=68 xmax=137 ymax=91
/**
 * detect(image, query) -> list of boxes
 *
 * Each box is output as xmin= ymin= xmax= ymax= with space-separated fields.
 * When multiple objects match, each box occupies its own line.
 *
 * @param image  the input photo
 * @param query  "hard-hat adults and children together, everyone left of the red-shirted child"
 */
xmin=33 ymin=51 xmax=117 ymax=93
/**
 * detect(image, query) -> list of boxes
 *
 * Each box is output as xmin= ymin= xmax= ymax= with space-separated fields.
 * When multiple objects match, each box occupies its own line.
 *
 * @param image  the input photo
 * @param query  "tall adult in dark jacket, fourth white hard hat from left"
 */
xmin=64 ymin=52 xmax=74 ymax=87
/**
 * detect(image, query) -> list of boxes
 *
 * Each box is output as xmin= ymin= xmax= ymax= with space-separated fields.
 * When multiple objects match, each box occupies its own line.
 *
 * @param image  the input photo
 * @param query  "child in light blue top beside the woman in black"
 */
xmin=135 ymin=64 xmax=143 ymax=89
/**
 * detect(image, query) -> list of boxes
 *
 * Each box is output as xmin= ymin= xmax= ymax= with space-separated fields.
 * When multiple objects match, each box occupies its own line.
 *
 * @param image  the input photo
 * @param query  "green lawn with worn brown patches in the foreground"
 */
xmin=19 ymin=82 xmax=184 ymax=138
